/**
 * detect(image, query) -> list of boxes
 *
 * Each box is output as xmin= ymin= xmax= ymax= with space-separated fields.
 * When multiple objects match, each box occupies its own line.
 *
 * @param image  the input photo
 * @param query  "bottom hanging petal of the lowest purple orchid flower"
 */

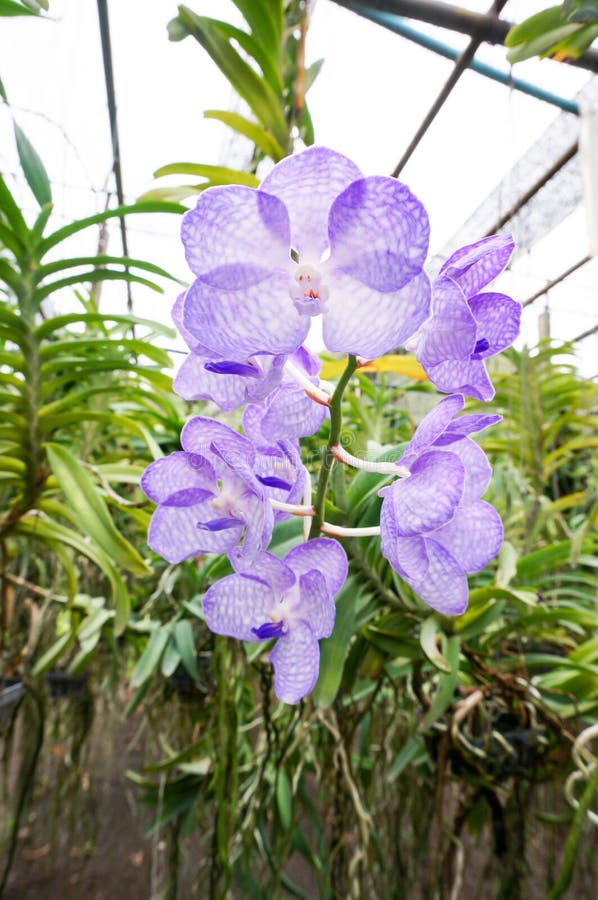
xmin=270 ymin=624 xmax=320 ymax=703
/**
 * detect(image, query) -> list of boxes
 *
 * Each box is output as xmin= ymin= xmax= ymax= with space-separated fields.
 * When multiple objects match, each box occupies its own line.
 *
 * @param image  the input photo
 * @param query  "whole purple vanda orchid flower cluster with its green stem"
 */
xmin=142 ymin=147 xmax=520 ymax=703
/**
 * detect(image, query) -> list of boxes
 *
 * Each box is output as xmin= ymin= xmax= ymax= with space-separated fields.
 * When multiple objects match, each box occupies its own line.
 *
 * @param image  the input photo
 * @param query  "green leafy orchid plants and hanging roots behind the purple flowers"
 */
xmin=0 ymin=0 xmax=598 ymax=898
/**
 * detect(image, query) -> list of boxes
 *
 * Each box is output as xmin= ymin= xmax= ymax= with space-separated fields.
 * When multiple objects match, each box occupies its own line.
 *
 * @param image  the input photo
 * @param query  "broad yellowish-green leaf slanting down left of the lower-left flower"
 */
xmin=46 ymin=444 xmax=151 ymax=575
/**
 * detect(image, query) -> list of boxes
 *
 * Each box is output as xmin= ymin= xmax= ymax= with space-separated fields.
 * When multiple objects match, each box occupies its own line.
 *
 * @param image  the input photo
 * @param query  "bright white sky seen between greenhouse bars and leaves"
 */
xmin=0 ymin=0 xmax=598 ymax=375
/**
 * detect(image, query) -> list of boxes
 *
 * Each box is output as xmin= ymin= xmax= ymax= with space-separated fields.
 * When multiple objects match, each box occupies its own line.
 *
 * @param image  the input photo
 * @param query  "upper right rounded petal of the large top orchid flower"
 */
xmin=328 ymin=176 xmax=430 ymax=293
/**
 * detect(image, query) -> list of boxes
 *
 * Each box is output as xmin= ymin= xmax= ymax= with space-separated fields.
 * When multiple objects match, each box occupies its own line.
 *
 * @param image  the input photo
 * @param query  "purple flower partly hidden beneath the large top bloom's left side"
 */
xmin=172 ymin=294 xmax=287 ymax=412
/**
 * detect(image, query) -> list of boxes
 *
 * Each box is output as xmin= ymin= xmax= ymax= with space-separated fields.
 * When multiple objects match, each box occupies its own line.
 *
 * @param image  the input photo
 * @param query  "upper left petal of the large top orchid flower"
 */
xmin=181 ymin=185 xmax=291 ymax=275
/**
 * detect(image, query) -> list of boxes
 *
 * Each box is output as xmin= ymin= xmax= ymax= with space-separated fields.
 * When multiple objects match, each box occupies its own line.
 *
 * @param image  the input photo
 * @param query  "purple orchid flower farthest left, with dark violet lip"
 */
xmin=141 ymin=416 xmax=280 ymax=563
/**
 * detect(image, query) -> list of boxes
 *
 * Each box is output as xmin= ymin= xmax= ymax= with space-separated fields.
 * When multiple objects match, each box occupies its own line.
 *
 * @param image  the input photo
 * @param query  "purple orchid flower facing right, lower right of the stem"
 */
xmin=380 ymin=395 xmax=503 ymax=616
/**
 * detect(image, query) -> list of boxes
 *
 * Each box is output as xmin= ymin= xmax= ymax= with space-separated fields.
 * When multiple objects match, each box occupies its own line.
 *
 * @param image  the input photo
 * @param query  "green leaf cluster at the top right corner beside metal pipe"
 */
xmin=505 ymin=0 xmax=598 ymax=63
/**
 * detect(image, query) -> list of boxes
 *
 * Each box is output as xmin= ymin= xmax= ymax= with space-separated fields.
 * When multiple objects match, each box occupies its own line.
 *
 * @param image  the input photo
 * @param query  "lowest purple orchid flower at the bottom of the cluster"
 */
xmin=203 ymin=538 xmax=347 ymax=703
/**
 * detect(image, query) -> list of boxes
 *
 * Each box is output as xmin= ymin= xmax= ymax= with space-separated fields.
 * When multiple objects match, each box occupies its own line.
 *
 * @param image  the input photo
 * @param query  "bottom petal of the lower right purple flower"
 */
xmin=406 ymin=538 xmax=468 ymax=616
